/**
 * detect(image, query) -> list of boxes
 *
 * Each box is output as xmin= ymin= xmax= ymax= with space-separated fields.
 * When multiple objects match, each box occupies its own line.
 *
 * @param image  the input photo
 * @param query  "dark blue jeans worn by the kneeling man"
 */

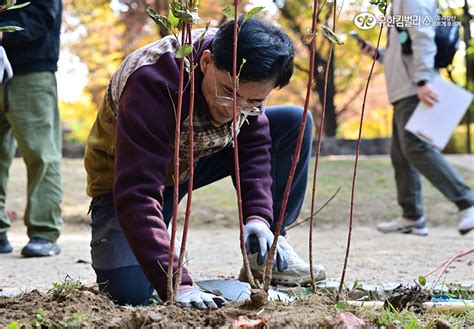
xmin=91 ymin=105 xmax=313 ymax=305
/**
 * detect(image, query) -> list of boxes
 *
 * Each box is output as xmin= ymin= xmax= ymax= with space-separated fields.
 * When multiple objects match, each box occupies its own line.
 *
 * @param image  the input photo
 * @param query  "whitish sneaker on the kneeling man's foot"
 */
xmin=239 ymin=235 xmax=326 ymax=286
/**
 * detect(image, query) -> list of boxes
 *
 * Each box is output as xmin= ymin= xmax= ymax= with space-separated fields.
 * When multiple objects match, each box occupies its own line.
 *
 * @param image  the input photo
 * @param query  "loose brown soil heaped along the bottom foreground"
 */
xmin=0 ymin=289 xmax=344 ymax=328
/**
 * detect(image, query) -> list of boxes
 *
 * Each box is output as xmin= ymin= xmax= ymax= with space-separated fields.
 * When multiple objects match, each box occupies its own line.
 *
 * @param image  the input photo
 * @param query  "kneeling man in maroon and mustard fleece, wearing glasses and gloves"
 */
xmin=84 ymin=19 xmax=326 ymax=308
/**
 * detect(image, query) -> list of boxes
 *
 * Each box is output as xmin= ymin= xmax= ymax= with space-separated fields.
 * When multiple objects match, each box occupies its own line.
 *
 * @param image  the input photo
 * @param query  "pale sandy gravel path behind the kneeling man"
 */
xmin=0 ymin=222 xmax=474 ymax=295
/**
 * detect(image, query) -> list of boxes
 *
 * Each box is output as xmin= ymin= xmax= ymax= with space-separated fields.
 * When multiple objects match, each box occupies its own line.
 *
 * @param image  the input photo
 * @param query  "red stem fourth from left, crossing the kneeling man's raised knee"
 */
xmin=264 ymin=0 xmax=318 ymax=291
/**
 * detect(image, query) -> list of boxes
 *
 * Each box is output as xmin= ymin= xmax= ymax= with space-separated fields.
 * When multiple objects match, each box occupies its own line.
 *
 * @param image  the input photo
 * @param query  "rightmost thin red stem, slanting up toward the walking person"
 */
xmin=336 ymin=12 xmax=385 ymax=300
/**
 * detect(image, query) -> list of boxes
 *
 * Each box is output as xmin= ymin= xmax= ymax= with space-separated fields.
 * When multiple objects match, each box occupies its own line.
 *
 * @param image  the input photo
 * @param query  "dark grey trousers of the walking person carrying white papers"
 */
xmin=391 ymin=96 xmax=474 ymax=220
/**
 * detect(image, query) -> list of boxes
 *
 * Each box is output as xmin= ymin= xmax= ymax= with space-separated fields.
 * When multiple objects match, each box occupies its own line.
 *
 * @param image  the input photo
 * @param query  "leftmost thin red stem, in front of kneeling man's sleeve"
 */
xmin=166 ymin=23 xmax=186 ymax=303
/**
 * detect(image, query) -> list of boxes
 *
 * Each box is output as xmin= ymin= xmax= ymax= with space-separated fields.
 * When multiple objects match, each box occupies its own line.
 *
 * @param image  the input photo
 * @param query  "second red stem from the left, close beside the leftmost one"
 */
xmin=174 ymin=24 xmax=195 ymax=295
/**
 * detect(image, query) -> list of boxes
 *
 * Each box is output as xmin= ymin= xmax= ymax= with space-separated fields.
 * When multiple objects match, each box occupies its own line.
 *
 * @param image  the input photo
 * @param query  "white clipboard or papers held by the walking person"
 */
xmin=405 ymin=75 xmax=474 ymax=150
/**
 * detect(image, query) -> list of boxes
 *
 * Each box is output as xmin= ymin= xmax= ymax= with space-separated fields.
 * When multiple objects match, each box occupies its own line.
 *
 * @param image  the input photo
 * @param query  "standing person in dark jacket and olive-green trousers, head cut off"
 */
xmin=0 ymin=0 xmax=62 ymax=257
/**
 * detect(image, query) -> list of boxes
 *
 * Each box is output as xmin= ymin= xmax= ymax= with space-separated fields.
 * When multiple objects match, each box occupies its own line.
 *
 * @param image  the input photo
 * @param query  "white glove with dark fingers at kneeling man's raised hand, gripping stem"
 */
xmin=244 ymin=217 xmax=288 ymax=272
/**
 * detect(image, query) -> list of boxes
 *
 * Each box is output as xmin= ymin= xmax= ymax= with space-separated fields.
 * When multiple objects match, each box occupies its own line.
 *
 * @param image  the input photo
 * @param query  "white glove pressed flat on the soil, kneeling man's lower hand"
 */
xmin=176 ymin=286 xmax=227 ymax=310
